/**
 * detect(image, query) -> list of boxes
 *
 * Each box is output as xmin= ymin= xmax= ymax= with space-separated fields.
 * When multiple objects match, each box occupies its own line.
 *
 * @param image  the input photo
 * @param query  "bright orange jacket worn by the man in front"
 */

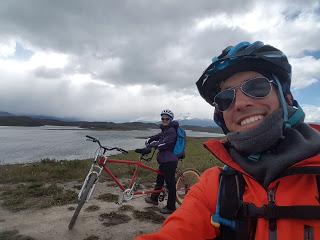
xmin=137 ymin=140 xmax=320 ymax=240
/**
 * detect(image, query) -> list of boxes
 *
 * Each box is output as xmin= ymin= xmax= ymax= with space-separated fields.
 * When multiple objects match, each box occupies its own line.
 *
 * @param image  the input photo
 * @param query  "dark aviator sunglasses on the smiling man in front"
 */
xmin=213 ymin=77 xmax=274 ymax=112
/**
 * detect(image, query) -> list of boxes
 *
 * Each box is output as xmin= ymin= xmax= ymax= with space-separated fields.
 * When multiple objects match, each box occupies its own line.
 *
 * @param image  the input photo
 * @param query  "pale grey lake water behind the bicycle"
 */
xmin=0 ymin=126 xmax=221 ymax=164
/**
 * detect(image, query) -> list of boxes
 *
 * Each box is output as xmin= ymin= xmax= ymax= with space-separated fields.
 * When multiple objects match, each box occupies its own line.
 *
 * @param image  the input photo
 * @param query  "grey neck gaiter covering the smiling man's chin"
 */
xmin=227 ymin=109 xmax=283 ymax=154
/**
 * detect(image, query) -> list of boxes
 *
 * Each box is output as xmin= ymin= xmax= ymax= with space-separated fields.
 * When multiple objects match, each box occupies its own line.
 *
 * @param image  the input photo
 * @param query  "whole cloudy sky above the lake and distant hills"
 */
xmin=0 ymin=0 xmax=320 ymax=121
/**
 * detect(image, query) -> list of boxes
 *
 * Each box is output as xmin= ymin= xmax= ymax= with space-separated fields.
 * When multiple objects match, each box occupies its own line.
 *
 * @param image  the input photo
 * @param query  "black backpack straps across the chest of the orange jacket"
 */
xmin=211 ymin=166 xmax=320 ymax=240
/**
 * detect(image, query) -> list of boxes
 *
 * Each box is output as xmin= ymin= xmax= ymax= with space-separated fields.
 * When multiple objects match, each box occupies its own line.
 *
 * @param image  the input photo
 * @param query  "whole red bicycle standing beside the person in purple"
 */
xmin=68 ymin=135 xmax=199 ymax=230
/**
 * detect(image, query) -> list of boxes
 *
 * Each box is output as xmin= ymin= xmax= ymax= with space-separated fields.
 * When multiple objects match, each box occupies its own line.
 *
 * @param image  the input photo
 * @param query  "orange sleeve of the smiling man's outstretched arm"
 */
xmin=136 ymin=168 xmax=220 ymax=240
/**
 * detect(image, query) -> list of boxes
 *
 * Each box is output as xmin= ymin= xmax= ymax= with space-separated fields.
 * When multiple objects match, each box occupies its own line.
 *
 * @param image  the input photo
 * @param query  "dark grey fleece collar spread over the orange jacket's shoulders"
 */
xmin=228 ymin=123 xmax=320 ymax=187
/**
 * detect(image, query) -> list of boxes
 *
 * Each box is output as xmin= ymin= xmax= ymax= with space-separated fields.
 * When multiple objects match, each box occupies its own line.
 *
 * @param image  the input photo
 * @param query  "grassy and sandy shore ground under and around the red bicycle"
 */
xmin=0 ymin=137 xmax=221 ymax=240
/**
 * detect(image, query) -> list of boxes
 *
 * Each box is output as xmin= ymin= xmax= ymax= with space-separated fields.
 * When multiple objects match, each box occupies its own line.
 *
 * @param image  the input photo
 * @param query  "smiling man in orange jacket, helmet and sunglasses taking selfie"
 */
xmin=139 ymin=42 xmax=320 ymax=240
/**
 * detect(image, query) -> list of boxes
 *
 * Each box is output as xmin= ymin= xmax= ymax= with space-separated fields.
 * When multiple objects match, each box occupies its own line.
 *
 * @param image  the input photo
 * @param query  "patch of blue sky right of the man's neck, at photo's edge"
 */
xmin=292 ymin=81 xmax=320 ymax=106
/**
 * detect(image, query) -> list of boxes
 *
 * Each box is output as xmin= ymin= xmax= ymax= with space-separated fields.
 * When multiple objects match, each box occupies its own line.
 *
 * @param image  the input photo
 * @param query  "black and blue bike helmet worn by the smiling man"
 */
xmin=196 ymin=41 xmax=304 ymax=133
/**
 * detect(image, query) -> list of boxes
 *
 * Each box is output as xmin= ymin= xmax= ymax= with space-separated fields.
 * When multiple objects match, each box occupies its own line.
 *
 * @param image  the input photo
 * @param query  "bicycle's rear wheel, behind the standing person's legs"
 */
xmin=176 ymin=169 xmax=200 ymax=204
